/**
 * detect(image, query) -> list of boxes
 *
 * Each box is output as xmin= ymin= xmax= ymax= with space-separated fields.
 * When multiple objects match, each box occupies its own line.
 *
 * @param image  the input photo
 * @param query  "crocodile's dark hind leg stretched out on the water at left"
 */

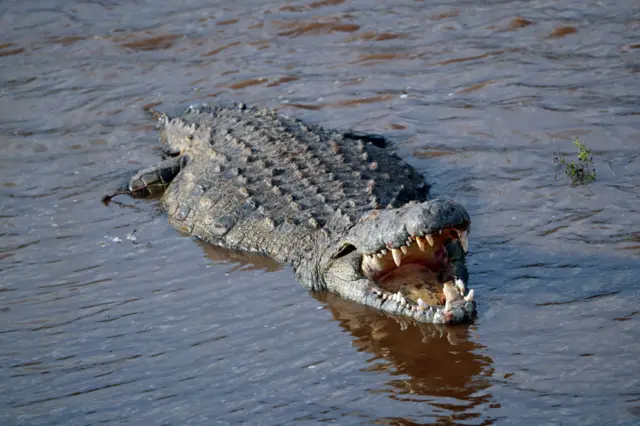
xmin=102 ymin=156 xmax=186 ymax=203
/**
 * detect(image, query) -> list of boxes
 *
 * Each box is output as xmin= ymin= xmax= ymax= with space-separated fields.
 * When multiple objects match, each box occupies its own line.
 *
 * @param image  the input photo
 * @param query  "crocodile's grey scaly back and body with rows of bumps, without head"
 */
xmin=163 ymin=105 xmax=428 ymax=262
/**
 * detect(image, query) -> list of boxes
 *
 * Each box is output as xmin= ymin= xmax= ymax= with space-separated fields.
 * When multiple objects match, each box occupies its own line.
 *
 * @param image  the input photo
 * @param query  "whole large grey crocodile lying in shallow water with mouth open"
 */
xmin=103 ymin=104 xmax=476 ymax=323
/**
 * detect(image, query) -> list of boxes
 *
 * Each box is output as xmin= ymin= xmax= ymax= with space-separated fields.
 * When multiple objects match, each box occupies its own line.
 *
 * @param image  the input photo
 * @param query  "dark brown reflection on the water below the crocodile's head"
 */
xmin=313 ymin=293 xmax=493 ymax=424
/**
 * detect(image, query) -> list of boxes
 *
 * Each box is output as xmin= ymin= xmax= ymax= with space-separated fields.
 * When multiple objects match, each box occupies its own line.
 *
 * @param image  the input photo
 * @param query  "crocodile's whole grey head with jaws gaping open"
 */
xmin=318 ymin=199 xmax=475 ymax=323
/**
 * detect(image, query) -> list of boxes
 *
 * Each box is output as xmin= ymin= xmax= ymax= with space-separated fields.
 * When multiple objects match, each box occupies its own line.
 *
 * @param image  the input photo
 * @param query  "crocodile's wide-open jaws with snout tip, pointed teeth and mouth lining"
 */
xmin=342 ymin=200 xmax=475 ymax=322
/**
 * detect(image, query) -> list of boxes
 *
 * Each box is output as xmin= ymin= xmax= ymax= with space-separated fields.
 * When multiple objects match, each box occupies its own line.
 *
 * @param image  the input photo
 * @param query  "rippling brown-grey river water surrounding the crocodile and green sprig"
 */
xmin=0 ymin=0 xmax=640 ymax=425
